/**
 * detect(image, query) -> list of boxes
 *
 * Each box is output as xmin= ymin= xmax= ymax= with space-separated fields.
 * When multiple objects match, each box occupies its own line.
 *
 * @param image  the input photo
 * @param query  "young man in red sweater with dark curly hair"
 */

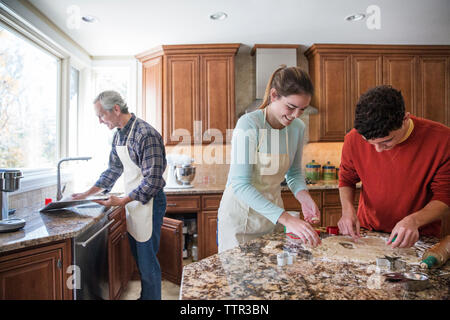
xmin=338 ymin=86 xmax=450 ymax=248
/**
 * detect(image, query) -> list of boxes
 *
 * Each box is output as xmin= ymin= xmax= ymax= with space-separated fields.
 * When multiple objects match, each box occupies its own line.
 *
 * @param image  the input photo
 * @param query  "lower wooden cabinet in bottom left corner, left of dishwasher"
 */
xmin=0 ymin=239 xmax=72 ymax=300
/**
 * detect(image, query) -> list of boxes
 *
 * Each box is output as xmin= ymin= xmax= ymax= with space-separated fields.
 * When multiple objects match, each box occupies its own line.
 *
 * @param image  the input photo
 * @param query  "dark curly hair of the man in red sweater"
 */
xmin=355 ymin=85 xmax=405 ymax=140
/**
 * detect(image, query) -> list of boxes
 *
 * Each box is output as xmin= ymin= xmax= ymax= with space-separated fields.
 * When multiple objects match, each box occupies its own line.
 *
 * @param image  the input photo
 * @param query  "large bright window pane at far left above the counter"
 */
xmin=0 ymin=25 xmax=59 ymax=168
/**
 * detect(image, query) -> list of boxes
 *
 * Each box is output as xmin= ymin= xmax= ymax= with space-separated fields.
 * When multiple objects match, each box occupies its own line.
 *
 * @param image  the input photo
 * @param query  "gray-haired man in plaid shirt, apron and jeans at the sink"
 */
xmin=72 ymin=91 xmax=166 ymax=300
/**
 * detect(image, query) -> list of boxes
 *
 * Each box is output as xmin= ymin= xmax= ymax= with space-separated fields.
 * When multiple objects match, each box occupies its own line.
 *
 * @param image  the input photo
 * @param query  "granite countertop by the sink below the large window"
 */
xmin=0 ymin=203 xmax=117 ymax=254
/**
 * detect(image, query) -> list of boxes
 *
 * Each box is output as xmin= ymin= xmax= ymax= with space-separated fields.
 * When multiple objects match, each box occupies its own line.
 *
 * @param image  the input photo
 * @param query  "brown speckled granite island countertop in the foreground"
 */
xmin=180 ymin=230 xmax=450 ymax=300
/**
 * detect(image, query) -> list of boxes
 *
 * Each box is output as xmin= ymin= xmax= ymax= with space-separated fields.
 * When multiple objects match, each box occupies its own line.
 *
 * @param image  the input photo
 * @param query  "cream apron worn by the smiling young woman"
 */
xmin=218 ymin=109 xmax=290 ymax=252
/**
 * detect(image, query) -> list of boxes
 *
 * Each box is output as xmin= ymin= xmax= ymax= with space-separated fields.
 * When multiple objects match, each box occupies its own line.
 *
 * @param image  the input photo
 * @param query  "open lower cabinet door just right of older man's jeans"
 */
xmin=158 ymin=217 xmax=183 ymax=284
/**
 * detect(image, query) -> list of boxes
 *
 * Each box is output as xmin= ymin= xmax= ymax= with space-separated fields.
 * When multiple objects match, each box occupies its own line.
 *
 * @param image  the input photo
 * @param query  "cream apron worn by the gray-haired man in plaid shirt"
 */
xmin=116 ymin=120 xmax=153 ymax=242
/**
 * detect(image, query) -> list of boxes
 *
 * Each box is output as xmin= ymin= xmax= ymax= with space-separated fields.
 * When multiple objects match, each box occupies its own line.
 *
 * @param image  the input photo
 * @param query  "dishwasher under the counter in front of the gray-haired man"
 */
xmin=72 ymin=214 xmax=114 ymax=300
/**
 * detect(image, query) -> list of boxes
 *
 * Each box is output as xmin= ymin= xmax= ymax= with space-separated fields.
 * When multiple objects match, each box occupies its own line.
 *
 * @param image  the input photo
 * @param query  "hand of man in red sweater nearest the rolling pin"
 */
xmin=386 ymin=215 xmax=419 ymax=248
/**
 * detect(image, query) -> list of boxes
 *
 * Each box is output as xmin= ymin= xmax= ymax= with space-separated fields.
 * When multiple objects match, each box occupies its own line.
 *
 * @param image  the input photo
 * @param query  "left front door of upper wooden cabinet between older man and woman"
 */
xmin=163 ymin=55 xmax=201 ymax=145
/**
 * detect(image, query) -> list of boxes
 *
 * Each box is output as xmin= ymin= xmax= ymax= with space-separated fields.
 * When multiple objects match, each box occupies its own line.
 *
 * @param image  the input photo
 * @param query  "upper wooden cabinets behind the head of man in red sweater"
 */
xmin=305 ymin=44 xmax=450 ymax=142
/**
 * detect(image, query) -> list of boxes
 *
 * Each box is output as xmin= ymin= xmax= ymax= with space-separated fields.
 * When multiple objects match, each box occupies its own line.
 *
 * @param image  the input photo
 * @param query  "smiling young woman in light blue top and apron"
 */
xmin=218 ymin=66 xmax=320 ymax=252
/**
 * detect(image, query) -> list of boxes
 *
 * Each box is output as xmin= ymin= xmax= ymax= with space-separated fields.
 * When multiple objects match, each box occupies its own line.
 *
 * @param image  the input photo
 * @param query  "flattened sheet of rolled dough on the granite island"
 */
xmin=308 ymin=236 xmax=420 ymax=263
